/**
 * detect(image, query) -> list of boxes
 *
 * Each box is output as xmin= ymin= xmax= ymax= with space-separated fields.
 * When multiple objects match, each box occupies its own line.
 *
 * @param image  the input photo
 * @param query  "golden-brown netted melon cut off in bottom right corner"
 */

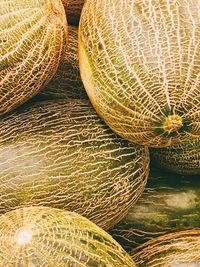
xmin=130 ymin=230 xmax=200 ymax=267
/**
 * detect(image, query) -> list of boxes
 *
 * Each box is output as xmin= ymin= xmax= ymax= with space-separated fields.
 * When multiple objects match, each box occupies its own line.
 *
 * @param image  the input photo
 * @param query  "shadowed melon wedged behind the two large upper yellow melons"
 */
xmin=34 ymin=26 xmax=87 ymax=100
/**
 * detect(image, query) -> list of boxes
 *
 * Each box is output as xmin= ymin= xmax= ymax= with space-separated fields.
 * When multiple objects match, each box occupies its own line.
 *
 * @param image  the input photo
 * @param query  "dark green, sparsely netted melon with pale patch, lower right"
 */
xmin=109 ymin=170 xmax=200 ymax=251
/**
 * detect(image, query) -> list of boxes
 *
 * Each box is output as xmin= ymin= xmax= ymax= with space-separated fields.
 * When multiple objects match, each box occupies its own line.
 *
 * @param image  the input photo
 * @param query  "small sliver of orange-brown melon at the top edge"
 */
xmin=62 ymin=0 xmax=86 ymax=25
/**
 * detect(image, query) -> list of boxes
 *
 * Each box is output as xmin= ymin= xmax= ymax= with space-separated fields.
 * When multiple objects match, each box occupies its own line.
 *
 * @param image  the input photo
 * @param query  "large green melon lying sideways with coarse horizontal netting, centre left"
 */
xmin=0 ymin=100 xmax=149 ymax=228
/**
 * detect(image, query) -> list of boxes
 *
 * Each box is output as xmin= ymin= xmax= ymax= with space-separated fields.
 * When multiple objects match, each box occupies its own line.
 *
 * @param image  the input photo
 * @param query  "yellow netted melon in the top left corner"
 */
xmin=0 ymin=0 xmax=67 ymax=114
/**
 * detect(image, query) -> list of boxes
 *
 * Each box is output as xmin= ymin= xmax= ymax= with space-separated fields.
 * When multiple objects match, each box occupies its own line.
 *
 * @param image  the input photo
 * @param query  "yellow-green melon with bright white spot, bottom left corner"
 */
xmin=0 ymin=207 xmax=135 ymax=267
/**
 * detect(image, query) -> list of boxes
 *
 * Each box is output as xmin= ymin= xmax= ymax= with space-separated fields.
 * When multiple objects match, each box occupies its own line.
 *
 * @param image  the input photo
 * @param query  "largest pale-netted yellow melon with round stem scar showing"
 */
xmin=79 ymin=0 xmax=200 ymax=147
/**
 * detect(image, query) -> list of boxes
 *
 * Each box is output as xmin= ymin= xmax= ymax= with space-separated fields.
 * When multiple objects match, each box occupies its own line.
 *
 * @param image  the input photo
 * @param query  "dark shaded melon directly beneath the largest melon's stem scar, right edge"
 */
xmin=150 ymin=139 xmax=200 ymax=175
